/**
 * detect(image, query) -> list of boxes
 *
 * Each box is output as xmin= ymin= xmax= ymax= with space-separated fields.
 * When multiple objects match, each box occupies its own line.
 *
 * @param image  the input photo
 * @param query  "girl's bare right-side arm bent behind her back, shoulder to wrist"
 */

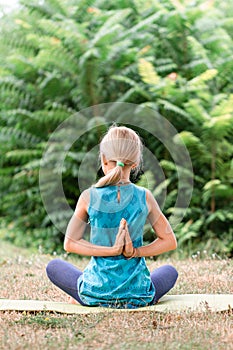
xmin=130 ymin=191 xmax=177 ymax=257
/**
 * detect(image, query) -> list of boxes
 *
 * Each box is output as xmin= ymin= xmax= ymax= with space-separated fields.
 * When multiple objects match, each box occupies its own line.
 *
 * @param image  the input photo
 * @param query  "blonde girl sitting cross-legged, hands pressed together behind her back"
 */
xmin=47 ymin=126 xmax=178 ymax=308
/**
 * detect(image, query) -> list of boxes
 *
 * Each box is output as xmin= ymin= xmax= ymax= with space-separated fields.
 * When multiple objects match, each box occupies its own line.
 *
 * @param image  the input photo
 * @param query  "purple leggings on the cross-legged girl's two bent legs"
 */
xmin=46 ymin=259 xmax=178 ymax=305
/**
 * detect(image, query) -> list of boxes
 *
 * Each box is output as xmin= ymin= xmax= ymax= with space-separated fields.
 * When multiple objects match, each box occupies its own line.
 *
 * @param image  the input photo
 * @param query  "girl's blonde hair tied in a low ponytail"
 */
xmin=95 ymin=126 xmax=142 ymax=187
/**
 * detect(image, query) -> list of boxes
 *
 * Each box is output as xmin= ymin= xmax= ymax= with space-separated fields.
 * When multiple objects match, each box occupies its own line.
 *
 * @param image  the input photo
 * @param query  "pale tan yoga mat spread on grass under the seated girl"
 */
xmin=0 ymin=294 xmax=233 ymax=314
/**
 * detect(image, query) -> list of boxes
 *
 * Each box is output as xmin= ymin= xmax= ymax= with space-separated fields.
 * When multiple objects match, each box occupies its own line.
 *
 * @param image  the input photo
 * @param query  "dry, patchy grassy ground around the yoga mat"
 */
xmin=0 ymin=242 xmax=233 ymax=350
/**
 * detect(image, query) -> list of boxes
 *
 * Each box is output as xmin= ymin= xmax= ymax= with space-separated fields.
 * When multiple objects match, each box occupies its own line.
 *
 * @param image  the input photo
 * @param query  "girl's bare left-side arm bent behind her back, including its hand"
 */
xmin=64 ymin=191 xmax=124 ymax=256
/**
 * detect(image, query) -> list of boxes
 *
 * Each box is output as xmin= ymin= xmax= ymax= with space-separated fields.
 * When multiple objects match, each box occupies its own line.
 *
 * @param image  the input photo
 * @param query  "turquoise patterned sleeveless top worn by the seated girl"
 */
xmin=77 ymin=184 xmax=155 ymax=308
